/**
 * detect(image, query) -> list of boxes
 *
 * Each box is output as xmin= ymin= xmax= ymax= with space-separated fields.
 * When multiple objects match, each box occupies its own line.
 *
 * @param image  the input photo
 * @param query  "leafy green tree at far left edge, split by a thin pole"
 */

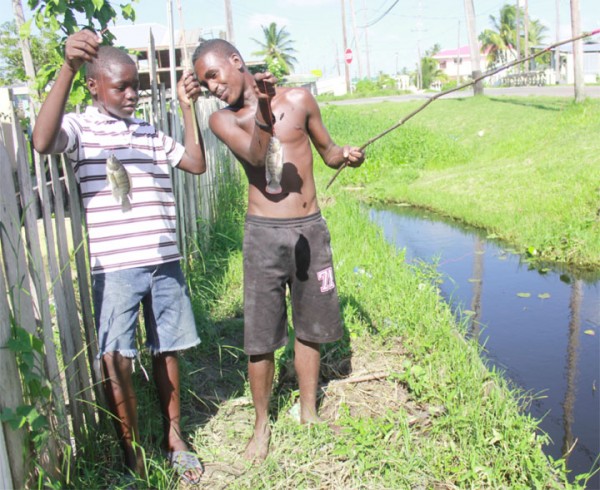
xmin=0 ymin=21 xmax=62 ymax=86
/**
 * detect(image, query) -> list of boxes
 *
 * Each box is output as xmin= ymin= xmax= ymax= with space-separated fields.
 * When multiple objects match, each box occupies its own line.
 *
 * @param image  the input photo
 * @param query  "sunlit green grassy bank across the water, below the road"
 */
xmin=323 ymin=97 xmax=600 ymax=268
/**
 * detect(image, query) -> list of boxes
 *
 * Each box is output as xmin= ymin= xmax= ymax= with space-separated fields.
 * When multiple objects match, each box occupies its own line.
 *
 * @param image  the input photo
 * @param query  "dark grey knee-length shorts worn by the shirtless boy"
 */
xmin=244 ymin=212 xmax=343 ymax=355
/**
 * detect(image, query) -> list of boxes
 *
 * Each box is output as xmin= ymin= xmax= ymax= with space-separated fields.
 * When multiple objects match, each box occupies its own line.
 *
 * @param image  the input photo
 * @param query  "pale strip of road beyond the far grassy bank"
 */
xmin=328 ymin=85 xmax=600 ymax=105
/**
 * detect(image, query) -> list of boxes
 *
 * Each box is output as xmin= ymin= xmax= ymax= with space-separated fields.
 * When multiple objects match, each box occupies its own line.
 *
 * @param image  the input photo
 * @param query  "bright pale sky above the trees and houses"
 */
xmin=0 ymin=0 xmax=600 ymax=78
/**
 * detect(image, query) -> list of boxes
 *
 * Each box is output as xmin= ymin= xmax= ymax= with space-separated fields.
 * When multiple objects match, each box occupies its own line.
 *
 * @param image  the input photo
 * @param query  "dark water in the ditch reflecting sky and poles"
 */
xmin=370 ymin=207 xmax=600 ymax=488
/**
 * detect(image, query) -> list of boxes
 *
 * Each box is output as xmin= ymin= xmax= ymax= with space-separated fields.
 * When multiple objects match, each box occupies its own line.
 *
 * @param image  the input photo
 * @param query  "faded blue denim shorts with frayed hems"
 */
xmin=92 ymin=262 xmax=200 ymax=358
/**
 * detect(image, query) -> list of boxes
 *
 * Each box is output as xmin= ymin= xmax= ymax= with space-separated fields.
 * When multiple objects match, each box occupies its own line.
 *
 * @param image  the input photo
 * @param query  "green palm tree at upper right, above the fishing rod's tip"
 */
xmin=479 ymin=4 xmax=547 ymax=66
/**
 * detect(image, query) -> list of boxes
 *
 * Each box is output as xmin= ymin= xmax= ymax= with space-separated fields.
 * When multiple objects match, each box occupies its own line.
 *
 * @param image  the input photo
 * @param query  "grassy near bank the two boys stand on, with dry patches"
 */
xmin=70 ymin=173 xmax=592 ymax=489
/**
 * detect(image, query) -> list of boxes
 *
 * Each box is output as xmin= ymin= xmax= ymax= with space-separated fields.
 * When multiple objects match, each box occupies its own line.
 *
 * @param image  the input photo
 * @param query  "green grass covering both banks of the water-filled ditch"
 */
xmin=56 ymin=99 xmax=599 ymax=489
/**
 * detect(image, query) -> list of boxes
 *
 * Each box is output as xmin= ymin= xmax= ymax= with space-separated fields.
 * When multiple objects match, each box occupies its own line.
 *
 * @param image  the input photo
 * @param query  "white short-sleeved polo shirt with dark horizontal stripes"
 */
xmin=62 ymin=106 xmax=185 ymax=274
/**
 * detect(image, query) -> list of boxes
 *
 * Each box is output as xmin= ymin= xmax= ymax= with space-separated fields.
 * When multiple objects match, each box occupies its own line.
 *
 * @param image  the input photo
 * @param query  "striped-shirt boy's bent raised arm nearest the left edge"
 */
xmin=32 ymin=29 xmax=100 ymax=154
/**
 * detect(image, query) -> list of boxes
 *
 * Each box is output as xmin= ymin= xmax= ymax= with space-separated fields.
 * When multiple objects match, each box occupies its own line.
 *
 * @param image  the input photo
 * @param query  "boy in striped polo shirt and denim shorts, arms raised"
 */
xmin=33 ymin=30 xmax=206 ymax=483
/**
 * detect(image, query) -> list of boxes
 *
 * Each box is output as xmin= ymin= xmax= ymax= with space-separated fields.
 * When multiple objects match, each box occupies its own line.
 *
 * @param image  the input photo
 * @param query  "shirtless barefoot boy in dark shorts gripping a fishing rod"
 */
xmin=193 ymin=39 xmax=364 ymax=461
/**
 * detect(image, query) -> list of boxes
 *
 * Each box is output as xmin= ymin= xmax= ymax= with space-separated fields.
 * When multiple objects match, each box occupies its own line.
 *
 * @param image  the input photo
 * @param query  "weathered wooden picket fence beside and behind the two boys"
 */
xmin=0 ymin=90 xmax=239 ymax=489
